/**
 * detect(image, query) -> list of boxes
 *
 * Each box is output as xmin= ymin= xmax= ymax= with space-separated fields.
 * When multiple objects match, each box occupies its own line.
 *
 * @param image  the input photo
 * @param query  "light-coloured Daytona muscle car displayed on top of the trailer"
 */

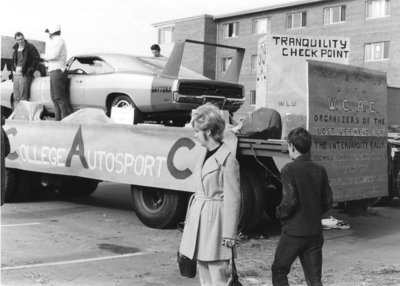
xmin=1 ymin=40 xmax=244 ymax=126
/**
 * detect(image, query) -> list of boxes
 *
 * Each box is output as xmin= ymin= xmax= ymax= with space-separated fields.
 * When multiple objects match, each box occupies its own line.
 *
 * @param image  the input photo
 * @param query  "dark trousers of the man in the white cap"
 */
xmin=50 ymin=69 xmax=72 ymax=121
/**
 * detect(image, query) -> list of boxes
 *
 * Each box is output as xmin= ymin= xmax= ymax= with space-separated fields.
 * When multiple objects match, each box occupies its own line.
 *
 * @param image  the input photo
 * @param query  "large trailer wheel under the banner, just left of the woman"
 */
xmin=131 ymin=185 xmax=188 ymax=228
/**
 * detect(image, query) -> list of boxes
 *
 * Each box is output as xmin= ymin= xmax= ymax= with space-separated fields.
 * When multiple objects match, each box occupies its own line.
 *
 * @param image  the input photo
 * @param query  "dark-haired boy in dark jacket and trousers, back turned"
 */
xmin=271 ymin=127 xmax=332 ymax=286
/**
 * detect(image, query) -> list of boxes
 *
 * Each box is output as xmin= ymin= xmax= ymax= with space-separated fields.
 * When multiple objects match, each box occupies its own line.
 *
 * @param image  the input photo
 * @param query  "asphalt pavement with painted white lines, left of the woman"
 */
xmin=1 ymin=183 xmax=198 ymax=286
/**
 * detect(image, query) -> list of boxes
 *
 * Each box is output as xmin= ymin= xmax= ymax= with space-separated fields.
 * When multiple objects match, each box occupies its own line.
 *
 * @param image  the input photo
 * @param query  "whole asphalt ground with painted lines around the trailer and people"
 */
xmin=1 ymin=183 xmax=400 ymax=286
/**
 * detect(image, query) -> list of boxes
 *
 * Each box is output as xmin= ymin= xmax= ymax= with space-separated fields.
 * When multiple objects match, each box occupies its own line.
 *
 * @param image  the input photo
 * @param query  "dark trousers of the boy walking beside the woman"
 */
xmin=271 ymin=234 xmax=324 ymax=286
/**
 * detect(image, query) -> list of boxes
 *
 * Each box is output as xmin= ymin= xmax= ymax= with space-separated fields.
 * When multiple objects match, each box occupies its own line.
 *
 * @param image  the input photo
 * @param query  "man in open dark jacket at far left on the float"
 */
xmin=12 ymin=32 xmax=40 ymax=106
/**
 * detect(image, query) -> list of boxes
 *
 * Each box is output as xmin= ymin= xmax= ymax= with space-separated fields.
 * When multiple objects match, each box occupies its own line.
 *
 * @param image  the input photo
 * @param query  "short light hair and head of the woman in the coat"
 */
xmin=192 ymin=103 xmax=225 ymax=142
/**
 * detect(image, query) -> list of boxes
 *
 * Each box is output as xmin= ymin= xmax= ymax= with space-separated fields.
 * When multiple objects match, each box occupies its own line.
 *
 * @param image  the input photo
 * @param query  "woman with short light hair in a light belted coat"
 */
xmin=179 ymin=104 xmax=240 ymax=286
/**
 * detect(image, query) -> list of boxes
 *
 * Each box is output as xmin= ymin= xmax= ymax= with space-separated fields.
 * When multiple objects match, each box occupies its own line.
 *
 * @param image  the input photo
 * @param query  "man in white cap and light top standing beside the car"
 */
xmin=40 ymin=24 xmax=72 ymax=121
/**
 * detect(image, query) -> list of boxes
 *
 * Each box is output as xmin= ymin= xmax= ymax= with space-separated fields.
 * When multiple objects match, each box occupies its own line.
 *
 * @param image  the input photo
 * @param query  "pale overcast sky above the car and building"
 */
xmin=0 ymin=0 xmax=298 ymax=56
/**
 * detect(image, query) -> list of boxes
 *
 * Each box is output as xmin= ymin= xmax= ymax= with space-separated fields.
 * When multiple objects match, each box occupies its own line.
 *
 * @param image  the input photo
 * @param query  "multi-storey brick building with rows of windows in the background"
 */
xmin=153 ymin=0 xmax=400 ymax=117
